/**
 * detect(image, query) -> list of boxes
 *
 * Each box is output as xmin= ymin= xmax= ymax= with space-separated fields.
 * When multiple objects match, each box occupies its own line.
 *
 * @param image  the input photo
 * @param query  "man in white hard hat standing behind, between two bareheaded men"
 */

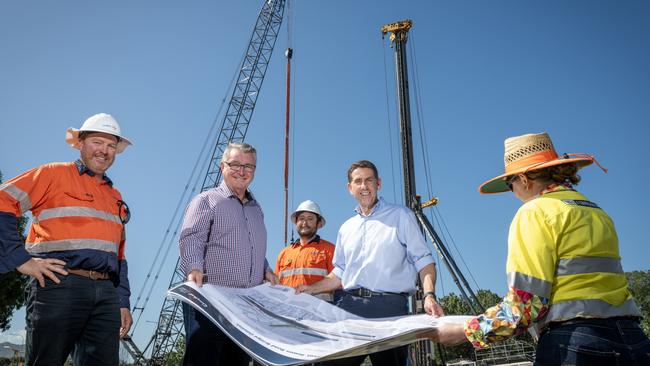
xmin=275 ymin=200 xmax=334 ymax=302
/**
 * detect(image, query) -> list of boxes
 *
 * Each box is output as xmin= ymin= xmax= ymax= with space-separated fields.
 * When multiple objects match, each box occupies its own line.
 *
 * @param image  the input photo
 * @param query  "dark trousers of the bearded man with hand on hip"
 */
xmin=25 ymin=274 xmax=121 ymax=366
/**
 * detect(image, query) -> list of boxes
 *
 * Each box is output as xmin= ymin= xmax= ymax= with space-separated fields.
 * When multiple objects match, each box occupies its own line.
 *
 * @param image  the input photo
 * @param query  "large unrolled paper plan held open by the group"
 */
xmin=168 ymin=282 xmax=467 ymax=366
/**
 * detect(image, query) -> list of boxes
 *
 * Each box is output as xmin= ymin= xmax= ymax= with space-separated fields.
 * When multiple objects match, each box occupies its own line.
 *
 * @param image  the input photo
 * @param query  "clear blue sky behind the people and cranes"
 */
xmin=0 ymin=0 xmax=650 ymax=356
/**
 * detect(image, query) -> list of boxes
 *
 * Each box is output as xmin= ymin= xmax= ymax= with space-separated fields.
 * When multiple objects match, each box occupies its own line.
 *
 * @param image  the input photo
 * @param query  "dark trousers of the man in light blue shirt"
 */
xmin=319 ymin=293 xmax=408 ymax=366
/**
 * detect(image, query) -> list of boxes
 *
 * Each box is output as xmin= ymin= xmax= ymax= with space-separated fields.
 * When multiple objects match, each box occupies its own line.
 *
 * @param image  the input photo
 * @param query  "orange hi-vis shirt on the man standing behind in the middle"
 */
xmin=275 ymin=235 xmax=334 ymax=287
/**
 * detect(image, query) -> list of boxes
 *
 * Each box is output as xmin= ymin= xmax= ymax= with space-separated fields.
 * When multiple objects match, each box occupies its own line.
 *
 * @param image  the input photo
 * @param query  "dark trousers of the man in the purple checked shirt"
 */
xmin=183 ymin=303 xmax=251 ymax=366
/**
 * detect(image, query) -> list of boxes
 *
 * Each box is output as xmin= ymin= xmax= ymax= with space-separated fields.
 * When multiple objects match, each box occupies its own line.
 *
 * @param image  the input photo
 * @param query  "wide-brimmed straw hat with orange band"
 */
xmin=478 ymin=132 xmax=594 ymax=193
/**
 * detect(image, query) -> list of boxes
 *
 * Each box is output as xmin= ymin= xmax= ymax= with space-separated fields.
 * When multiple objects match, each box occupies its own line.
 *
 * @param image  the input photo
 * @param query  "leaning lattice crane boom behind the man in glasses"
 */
xmin=122 ymin=0 xmax=285 ymax=365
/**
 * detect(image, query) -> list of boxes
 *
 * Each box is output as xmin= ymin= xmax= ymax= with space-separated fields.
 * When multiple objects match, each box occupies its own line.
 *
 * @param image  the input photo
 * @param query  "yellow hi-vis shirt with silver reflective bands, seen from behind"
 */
xmin=506 ymin=186 xmax=640 ymax=329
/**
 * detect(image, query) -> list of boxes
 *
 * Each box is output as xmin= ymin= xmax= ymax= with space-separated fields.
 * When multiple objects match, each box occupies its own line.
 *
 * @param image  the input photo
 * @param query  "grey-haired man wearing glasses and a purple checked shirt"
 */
xmin=180 ymin=143 xmax=277 ymax=366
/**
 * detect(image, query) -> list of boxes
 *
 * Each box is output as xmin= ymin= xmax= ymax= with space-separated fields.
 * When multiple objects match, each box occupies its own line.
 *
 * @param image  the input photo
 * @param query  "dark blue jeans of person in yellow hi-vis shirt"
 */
xmin=535 ymin=318 xmax=650 ymax=366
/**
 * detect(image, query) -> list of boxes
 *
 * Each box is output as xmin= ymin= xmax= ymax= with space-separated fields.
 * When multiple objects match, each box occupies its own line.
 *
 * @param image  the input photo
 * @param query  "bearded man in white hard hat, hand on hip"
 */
xmin=0 ymin=113 xmax=132 ymax=366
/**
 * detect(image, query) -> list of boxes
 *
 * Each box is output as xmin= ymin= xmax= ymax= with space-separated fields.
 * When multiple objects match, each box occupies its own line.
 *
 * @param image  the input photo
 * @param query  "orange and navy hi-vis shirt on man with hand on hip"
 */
xmin=0 ymin=160 xmax=131 ymax=309
